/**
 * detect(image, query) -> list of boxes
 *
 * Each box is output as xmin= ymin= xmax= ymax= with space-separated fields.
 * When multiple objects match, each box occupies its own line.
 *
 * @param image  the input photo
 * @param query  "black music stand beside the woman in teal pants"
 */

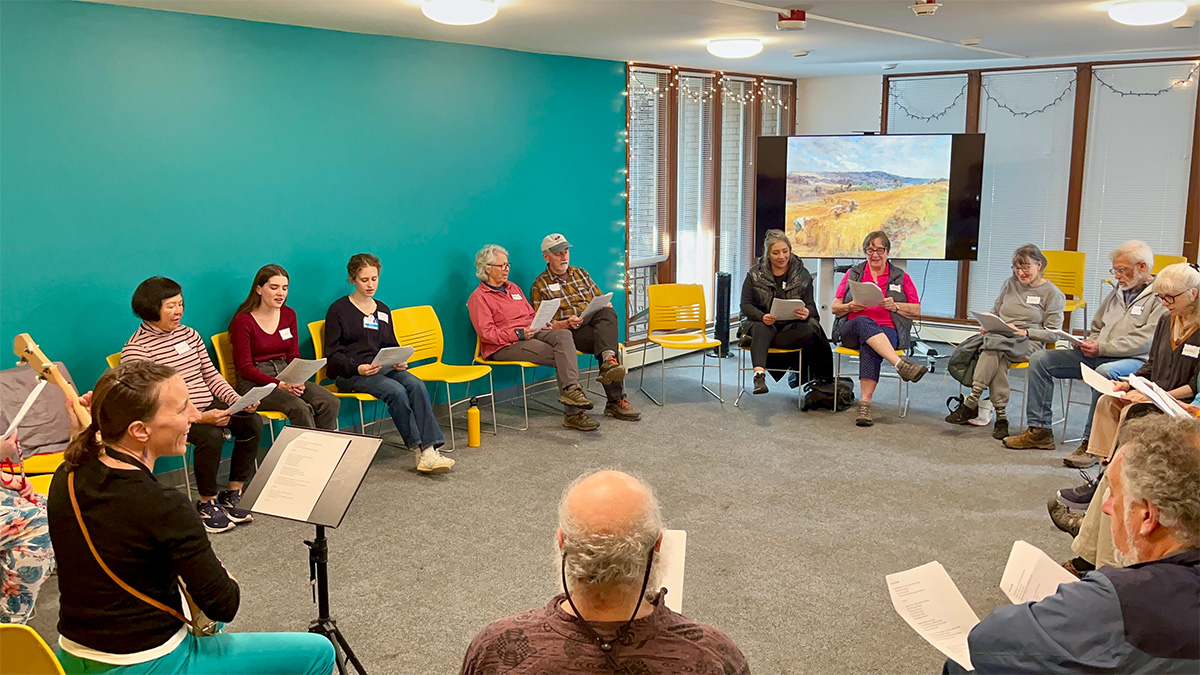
xmin=240 ymin=426 xmax=383 ymax=675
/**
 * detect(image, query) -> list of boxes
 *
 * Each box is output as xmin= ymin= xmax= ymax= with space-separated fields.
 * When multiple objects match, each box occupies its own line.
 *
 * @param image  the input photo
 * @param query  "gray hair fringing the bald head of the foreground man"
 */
xmin=556 ymin=472 xmax=662 ymax=597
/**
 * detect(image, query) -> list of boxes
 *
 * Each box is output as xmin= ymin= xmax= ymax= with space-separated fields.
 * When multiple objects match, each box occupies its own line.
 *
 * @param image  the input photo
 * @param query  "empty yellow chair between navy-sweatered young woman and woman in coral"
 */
xmin=391 ymin=305 xmax=496 ymax=450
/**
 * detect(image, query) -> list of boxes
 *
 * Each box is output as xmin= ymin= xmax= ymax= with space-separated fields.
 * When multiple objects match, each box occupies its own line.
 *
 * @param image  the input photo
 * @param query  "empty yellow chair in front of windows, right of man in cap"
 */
xmin=637 ymin=283 xmax=725 ymax=406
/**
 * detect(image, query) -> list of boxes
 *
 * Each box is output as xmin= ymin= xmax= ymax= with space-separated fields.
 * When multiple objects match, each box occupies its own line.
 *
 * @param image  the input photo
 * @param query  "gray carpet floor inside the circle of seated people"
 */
xmin=32 ymin=348 xmax=1086 ymax=674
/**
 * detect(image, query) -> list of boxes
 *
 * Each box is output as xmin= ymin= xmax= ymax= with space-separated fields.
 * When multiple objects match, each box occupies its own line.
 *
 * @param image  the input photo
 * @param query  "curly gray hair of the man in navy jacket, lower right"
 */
xmin=1121 ymin=414 xmax=1200 ymax=546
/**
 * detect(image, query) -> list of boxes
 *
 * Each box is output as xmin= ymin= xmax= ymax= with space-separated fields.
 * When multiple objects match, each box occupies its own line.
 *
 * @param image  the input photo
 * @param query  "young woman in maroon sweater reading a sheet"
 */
xmin=229 ymin=264 xmax=342 ymax=430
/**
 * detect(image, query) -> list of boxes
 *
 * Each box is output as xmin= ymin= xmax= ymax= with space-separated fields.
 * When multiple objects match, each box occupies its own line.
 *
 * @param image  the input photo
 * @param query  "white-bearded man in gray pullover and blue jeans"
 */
xmin=1004 ymin=240 xmax=1166 ymax=461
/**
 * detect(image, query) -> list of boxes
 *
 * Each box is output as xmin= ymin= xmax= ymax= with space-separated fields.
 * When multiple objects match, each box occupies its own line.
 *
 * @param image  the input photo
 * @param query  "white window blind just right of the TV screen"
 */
xmin=968 ymin=68 xmax=1082 ymax=323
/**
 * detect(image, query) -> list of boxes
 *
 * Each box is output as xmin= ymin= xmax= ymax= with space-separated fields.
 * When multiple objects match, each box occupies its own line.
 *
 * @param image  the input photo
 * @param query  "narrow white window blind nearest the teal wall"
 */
xmin=628 ymin=68 xmax=671 ymax=268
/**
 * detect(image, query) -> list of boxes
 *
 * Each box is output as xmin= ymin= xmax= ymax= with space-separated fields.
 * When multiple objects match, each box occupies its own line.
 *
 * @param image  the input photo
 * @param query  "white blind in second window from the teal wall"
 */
xmin=674 ymin=73 xmax=716 ymax=318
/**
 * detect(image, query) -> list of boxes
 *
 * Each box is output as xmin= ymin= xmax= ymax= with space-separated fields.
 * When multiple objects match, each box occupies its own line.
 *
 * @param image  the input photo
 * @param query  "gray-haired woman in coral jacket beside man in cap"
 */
xmin=467 ymin=244 xmax=600 ymax=431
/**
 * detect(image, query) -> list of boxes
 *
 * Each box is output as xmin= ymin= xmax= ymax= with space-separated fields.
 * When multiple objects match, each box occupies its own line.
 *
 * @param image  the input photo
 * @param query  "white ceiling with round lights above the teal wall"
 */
xmin=92 ymin=0 xmax=1200 ymax=77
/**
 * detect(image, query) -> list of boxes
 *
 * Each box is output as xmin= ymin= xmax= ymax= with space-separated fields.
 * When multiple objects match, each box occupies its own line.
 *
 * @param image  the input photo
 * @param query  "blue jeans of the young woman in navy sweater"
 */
xmin=337 ymin=368 xmax=445 ymax=448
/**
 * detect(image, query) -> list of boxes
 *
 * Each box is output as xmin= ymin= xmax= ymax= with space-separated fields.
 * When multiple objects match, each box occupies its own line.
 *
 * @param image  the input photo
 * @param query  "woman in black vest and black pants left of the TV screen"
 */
xmin=738 ymin=229 xmax=833 ymax=394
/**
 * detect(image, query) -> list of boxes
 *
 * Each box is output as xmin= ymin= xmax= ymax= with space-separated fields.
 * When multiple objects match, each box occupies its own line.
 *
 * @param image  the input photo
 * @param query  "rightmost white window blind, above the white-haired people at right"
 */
xmin=1079 ymin=61 xmax=1198 ymax=315
